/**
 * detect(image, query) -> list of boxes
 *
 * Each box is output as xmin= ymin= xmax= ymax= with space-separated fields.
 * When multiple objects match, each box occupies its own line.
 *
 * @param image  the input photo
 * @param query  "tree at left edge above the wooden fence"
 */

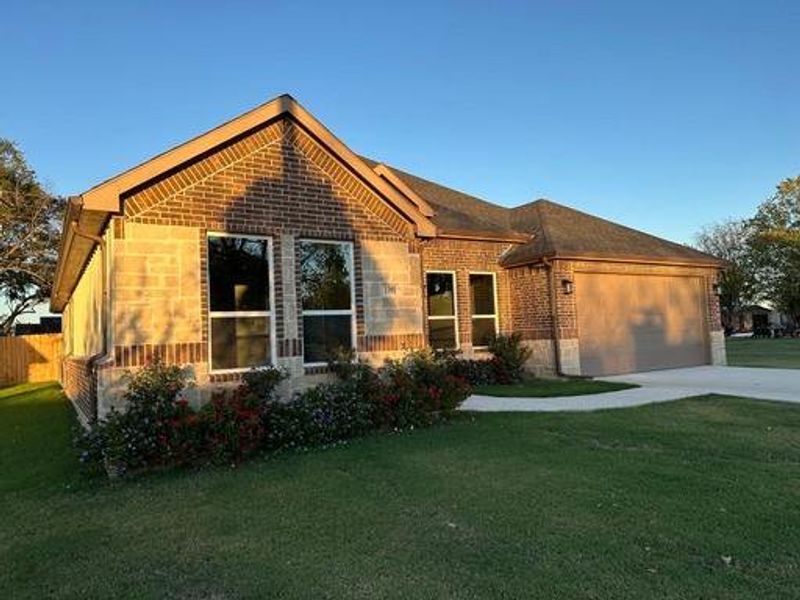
xmin=0 ymin=138 xmax=63 ymax=335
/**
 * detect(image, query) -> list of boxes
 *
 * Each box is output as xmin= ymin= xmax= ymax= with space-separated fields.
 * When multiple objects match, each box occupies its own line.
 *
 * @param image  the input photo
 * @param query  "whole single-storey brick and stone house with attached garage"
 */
xmin=51 ymin=96 xmax=725 ymax=418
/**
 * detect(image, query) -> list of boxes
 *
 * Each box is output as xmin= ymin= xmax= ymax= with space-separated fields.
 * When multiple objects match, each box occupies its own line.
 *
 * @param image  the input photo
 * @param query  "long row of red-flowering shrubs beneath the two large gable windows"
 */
xmin=73 ymin=351 xmax=470 ymax=474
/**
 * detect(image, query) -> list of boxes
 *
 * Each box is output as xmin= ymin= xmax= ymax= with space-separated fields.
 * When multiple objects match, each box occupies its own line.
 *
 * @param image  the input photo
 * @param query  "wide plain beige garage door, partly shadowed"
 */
xmin=575 ymin=273 xmax=709 ymax=375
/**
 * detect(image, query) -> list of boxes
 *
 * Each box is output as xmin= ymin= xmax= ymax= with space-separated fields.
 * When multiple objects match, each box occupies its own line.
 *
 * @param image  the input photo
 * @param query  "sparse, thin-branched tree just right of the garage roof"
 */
xmin=697 ymin=220 xmax=758 ymax=330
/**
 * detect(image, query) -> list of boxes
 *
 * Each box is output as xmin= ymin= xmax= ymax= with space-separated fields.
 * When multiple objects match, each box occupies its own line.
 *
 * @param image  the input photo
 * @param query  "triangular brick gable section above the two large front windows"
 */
xmin=125 ymin=120 xmax=413 ymax=239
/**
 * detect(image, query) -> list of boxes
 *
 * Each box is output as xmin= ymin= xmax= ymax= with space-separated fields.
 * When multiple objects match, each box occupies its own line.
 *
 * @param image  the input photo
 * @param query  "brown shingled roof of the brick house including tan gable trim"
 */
xmin=50 ymin=94 xmax=722 ymax=312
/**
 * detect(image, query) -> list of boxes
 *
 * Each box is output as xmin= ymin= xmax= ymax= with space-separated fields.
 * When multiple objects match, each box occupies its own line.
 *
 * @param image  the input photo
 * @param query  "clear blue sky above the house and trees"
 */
xmin=0 ymin=0 xmax=800 ymax=242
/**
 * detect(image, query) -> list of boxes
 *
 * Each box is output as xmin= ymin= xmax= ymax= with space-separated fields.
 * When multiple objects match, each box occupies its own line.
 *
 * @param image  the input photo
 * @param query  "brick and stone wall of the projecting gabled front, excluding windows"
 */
xmin=94 ymin=115 xmax=432 ymax=410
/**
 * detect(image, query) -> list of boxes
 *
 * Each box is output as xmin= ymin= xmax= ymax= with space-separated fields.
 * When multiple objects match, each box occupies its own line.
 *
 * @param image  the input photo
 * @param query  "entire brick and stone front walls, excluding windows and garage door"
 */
xmin=59 ymin=112 xmax=724 ymax=419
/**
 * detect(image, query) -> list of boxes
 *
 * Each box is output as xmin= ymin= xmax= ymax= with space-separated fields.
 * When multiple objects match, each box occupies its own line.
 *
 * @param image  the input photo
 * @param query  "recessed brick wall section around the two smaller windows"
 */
xmin=420 ymin=238 xmax=512 ymax=347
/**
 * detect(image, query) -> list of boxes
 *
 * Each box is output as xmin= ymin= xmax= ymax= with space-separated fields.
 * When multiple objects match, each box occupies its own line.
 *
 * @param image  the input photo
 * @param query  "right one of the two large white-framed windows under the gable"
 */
xmin=300 ymin=240 xmax=355 ymax=364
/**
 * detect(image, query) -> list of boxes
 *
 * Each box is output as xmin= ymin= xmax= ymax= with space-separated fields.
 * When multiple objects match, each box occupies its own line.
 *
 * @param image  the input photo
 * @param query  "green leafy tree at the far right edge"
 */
xmin=751 ymin=177 xmax=800 ymax=326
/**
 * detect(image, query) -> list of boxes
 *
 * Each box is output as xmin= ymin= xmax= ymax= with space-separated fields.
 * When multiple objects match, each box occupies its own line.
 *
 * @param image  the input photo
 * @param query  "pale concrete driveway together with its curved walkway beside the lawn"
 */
xmin=461 ymin=366 xmax=800 ymax=412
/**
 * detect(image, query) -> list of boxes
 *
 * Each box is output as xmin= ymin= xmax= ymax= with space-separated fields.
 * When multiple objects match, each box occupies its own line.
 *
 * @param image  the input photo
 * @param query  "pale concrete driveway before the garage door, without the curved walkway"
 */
xmin=599 ymin=366 xmax=800 ymax=402
